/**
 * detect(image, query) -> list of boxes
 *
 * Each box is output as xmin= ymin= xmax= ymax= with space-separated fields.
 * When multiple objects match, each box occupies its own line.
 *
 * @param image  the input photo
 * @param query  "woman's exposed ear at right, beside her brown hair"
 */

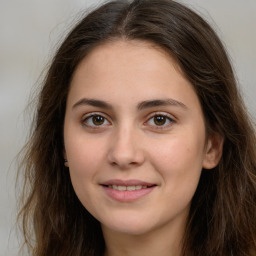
xmin=203 ymin=132 xmax=224 ymax=169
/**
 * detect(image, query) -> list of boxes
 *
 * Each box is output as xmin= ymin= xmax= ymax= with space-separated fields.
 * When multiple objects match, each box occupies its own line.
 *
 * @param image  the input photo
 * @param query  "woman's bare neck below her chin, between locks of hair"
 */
xmin=102 ymin=218 xmax=185 ymax=256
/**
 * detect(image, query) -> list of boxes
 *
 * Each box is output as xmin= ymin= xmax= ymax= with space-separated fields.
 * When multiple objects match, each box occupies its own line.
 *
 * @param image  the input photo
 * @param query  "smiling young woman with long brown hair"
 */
xmin=20 ymin=0 xmax=256 ymax=256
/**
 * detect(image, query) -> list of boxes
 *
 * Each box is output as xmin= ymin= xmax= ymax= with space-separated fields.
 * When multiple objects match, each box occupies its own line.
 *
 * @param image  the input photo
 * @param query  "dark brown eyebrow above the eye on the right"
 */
xmin=137 ymin=99 xmax=188 ymax=110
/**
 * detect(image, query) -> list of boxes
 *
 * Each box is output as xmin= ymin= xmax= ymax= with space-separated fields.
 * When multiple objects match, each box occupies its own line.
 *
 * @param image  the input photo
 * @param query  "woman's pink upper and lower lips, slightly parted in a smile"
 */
xmin=101 ymin=180 xmax=156 ymax=202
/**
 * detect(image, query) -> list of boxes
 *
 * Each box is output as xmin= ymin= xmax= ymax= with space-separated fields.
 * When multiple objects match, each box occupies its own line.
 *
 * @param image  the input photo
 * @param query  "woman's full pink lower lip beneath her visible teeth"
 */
xmin=103 ymin=186 xmax=156 ymax=202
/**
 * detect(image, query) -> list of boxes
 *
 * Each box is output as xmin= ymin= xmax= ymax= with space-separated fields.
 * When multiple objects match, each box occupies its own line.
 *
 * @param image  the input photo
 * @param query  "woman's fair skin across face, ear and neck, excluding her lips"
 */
xmin=64 ymin=40 xmax=222 ymax=256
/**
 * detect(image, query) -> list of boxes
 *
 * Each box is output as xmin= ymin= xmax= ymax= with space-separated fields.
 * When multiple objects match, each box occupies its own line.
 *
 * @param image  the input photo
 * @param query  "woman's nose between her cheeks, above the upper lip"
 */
xmin=108 ymin=125 xmax=145 ymax=169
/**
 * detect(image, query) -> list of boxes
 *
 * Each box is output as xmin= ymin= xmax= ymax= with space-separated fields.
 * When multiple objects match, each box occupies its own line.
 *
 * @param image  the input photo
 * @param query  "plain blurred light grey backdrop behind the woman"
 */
xmin=0 ymin=0 xmax=256 ymax=256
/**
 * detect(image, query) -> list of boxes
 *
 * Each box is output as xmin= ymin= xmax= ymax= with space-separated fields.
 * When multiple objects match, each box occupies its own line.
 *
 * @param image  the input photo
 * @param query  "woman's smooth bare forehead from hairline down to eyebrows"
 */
xmin=70 ymin=40 xmax=200 ymax=111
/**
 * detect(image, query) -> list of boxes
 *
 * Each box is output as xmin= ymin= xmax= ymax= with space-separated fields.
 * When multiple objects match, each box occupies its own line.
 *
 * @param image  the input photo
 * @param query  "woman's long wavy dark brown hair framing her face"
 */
xmin=20 ymin=0 xmax=256 ymax=256
